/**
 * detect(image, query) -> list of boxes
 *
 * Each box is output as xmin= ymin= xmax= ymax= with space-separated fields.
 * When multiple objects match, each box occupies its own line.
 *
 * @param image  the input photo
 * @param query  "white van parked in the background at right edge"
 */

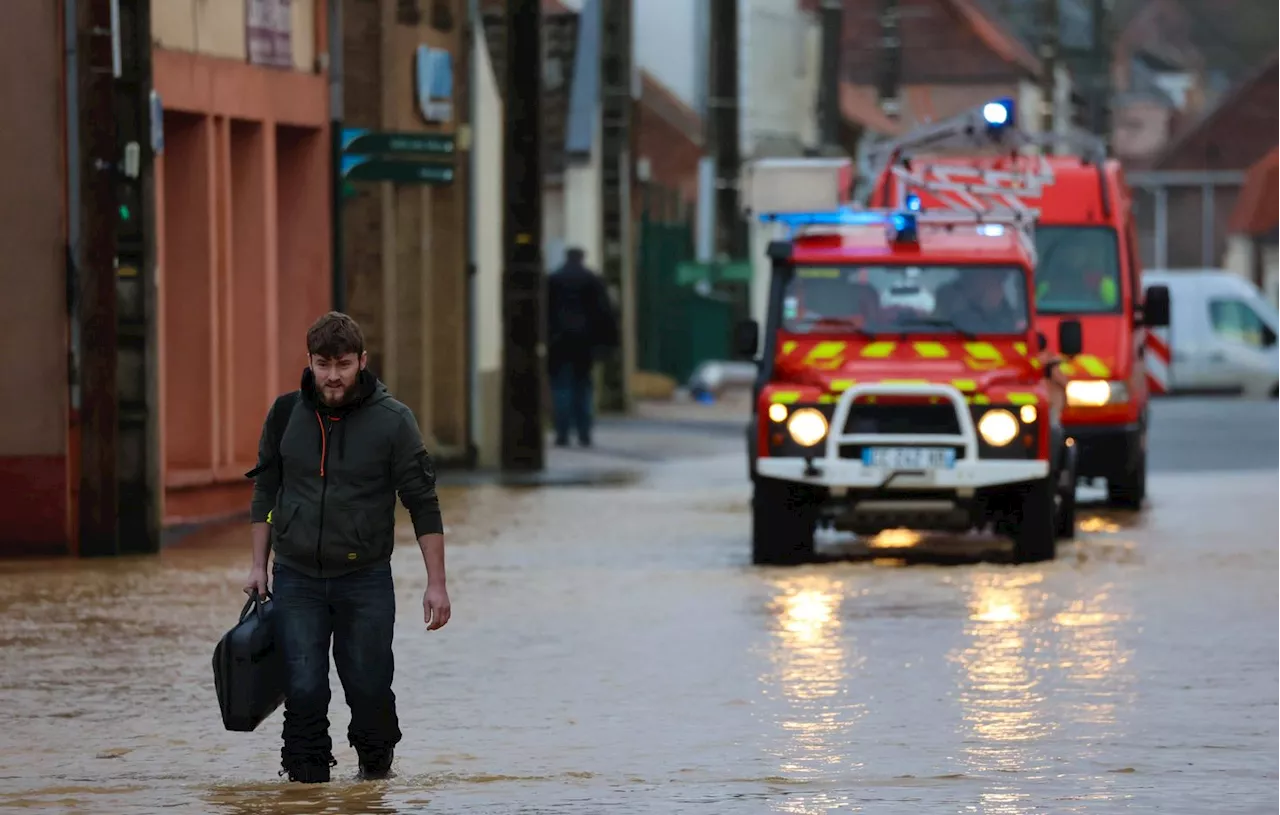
xmin=1142 ymin=269 xmax=1280 ymax=399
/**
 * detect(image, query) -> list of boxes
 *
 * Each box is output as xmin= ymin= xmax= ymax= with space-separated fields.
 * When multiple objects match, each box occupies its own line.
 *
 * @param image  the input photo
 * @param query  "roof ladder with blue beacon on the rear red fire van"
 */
xmin=865 ymin=99 xmax=1106 ymax=257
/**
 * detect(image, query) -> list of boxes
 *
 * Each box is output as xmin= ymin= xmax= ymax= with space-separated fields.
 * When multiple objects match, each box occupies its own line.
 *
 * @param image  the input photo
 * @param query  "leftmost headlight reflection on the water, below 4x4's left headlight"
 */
xmin=762 ymin=573 xmax=863 ymax=778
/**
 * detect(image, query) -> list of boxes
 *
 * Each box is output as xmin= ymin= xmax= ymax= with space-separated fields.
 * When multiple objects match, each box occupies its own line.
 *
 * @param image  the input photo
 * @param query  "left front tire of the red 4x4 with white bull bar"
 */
xmin=751 ymin=476 xmax=820 ymax=566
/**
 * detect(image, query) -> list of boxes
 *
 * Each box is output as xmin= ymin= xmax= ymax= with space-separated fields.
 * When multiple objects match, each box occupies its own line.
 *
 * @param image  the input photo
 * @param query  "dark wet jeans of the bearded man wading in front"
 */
xmin=271 ymin=563 xmax=401 ymax=768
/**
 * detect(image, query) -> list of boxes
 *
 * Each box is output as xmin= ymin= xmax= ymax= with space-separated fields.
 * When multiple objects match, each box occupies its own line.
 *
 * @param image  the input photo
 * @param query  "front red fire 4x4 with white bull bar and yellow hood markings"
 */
xmin=737 ymin=143 xmax=1083 ymax=564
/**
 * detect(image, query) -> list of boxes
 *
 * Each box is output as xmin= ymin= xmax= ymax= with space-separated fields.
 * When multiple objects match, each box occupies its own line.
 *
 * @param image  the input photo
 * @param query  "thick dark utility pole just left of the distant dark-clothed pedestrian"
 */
xmin=502 ymin=0 xmax=545 ymax=472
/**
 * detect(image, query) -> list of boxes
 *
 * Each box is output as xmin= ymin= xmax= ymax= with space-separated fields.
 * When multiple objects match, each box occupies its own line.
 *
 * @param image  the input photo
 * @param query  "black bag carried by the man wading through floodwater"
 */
xmin=214 ymin=591 xmax=287 ymax=733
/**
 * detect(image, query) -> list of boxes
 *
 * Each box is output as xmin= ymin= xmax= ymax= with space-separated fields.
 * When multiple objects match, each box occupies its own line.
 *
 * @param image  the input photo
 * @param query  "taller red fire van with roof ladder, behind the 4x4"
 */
xmin=869 ymin=99 xmax=1170 ymax=509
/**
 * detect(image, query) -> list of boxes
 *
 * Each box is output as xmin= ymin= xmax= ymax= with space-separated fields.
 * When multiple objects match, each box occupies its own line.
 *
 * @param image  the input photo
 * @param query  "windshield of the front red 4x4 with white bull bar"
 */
xmin=782 ymin=266 xmax=1028 ymax=336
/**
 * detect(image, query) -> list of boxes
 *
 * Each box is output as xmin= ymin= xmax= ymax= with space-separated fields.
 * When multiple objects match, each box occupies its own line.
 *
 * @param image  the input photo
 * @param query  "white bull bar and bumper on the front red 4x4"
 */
xmin=755 ymin=383 xmax=1048 ymax=493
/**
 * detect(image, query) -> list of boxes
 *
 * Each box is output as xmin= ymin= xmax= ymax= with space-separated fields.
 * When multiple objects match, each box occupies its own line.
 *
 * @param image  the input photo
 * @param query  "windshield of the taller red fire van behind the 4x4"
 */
xmin=1036 ymin=225 xmax=1124 ymax=315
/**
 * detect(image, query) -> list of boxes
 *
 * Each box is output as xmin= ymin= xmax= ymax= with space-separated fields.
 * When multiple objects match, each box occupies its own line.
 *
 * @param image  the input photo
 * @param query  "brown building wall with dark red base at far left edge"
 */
xmin=0 ymin=0 xmax=70 ymax=555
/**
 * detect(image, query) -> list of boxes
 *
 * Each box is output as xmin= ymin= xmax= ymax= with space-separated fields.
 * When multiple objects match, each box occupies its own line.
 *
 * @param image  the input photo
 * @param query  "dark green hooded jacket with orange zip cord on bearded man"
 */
xmin=251 ymin=368 xmax=444 ymax=577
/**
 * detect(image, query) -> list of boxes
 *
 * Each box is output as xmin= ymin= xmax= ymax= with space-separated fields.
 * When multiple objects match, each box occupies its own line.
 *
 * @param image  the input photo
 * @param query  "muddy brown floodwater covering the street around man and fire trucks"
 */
xmin=0 ymin=404 xmax=1280 ymax=815
